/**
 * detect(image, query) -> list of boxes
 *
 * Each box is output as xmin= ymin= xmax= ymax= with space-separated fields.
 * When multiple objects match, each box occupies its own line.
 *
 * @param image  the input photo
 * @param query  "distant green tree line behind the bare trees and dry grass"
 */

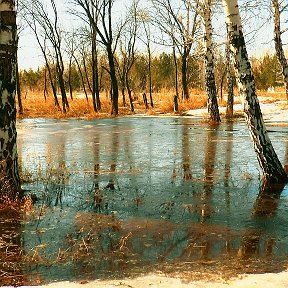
xmin=19 ymin=52 xmax=283 ymax=100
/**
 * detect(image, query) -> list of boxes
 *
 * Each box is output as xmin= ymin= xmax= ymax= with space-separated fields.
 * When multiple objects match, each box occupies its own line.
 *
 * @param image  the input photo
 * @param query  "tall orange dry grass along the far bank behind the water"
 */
xmin=18 ymin=89 xmax=286 ymax=119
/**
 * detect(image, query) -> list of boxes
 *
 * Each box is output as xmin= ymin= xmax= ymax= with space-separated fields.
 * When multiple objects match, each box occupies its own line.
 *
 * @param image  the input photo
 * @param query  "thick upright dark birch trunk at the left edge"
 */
xmin=0 ymin=0 xmax=21 ymax=198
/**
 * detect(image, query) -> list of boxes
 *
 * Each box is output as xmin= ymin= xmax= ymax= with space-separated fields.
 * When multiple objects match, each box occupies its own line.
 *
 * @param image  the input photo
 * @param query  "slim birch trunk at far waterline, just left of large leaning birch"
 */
xmin=203 ymin=0 xmax=221 ymax=122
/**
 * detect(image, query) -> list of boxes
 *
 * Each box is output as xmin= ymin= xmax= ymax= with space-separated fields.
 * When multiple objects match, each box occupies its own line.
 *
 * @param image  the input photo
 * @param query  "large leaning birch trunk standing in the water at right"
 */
xmin=222 ymin=0 xmax=287 ymax=183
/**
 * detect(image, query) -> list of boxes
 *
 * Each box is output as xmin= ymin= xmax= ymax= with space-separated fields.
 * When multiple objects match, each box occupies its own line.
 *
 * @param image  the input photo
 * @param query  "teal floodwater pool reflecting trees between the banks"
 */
xmin=0 ymin=117 xmax=288 ymax=284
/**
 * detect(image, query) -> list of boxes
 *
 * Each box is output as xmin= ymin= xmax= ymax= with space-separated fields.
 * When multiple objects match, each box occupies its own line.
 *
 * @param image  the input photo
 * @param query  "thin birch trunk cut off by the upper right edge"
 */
xmin=272 ymin=0 xmax=288 ymax=101
